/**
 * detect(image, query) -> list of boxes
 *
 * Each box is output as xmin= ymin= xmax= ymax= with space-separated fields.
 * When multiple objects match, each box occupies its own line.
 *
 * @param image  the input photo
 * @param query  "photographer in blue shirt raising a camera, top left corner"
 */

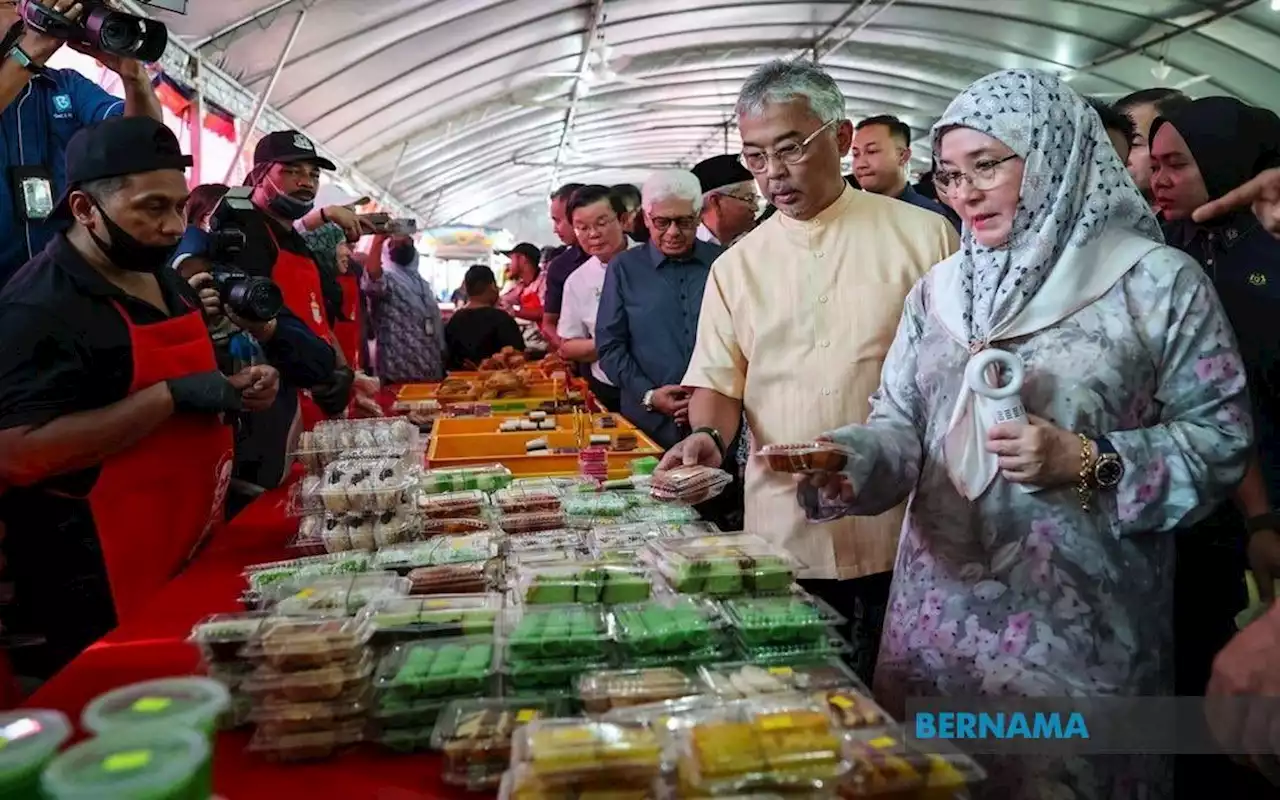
xmin=0 ymin=0 xmax=164 ymax=287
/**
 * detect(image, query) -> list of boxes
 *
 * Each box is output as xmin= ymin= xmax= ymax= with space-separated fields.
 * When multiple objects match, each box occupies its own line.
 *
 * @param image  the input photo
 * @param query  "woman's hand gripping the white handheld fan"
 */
xmin=987 ymin=415 xmax=1082 ymax=486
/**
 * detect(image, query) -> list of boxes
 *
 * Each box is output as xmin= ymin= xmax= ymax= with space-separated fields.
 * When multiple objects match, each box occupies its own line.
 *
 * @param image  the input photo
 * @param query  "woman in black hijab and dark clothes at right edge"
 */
xmin=1149 ymin=97 xmax=1280 ymax=796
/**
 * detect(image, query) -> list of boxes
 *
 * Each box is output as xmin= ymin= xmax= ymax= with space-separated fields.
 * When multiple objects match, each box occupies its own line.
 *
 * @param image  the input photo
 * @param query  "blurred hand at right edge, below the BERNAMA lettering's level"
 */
xmin=1204 ymin=604 xmax=1280 ymax=782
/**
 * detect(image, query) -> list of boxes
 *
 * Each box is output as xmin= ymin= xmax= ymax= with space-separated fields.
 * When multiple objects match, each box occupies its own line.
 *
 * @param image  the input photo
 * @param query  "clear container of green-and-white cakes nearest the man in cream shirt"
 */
xmin=650 ymin=534 xmax=800 ymax=596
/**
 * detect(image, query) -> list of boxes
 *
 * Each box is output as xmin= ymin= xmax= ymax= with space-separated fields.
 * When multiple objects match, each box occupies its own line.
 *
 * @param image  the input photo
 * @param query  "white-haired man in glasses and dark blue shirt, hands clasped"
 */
xmin=595 ymin=170 xmax=724 ymax=448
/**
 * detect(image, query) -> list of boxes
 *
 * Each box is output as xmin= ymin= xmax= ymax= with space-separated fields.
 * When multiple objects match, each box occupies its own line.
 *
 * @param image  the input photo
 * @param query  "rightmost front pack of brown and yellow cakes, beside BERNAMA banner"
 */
xmin=841 ymin=726 xmax=987 ymax=799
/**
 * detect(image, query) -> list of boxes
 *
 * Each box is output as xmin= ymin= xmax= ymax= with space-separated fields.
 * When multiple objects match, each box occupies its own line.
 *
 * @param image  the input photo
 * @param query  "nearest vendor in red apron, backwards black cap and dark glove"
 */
xmin=0 ymin=118 xmax=276 ymax=677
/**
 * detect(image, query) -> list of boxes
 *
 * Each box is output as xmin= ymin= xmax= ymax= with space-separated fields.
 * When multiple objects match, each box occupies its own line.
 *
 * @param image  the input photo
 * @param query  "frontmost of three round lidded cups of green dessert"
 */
xmin=41 ymin=727 xmax=210 ymax=800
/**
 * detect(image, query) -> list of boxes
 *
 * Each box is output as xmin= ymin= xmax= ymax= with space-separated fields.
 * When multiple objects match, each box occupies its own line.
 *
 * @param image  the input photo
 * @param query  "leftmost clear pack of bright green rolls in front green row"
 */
xmin=374 ymin=636 xmax=497 ymax=703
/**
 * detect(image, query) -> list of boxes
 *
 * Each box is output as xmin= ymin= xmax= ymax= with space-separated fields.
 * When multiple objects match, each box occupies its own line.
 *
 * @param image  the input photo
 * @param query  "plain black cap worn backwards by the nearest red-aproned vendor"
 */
xmin=50 ymin=116 xmax=192 ymax=219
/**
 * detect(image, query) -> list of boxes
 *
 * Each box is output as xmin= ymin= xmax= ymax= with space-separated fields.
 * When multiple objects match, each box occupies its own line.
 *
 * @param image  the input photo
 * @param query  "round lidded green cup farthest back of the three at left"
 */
xmin=81 ymin=677 xmax=230 ymax=737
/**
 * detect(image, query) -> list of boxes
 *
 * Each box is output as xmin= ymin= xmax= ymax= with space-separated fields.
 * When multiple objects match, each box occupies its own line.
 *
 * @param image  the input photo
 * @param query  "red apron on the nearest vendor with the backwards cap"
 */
xmin=88 ymin=303 xmax=234 ymax=623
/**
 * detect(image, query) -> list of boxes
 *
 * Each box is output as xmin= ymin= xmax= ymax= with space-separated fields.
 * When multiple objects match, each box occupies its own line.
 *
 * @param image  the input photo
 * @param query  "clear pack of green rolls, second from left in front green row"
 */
xmin=503 ymin=605 xmax=609 ymax=660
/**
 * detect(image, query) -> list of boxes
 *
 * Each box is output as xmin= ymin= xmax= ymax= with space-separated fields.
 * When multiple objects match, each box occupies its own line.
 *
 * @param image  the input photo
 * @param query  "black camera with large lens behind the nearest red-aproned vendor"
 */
xmin=209 ymin=186 xmax=284 ymax=323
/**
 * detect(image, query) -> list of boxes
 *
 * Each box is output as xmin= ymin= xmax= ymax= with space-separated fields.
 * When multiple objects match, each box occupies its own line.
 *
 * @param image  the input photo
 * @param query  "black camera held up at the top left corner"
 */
xmin=18 ymin=0 xmax=187 ymax=61
